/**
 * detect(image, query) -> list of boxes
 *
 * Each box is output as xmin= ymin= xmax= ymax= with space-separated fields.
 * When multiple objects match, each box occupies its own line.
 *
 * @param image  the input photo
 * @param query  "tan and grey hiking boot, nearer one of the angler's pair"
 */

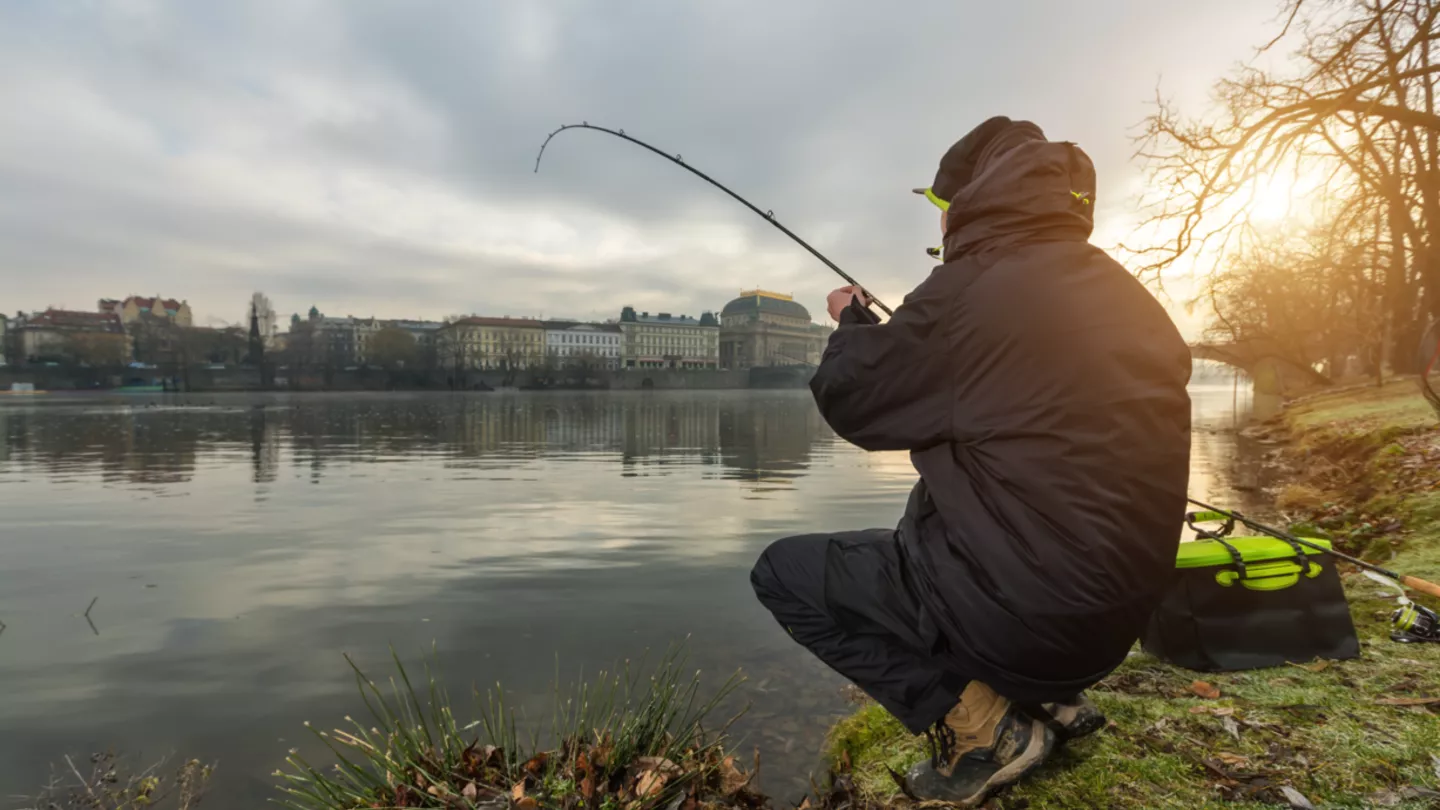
xmin=906 ymin=680 xmax=1056 ymax=807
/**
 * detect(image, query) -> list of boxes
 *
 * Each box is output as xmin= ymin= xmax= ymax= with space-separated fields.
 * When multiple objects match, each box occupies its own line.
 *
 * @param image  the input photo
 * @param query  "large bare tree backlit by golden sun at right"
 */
xmin=1122 ymin=0 xmax=1440 ymax=365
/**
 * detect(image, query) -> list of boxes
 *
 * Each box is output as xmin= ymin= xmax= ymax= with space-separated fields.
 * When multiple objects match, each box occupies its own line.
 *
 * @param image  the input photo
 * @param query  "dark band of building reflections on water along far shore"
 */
xmin=0 ymin=392 xmax=832 ymax=484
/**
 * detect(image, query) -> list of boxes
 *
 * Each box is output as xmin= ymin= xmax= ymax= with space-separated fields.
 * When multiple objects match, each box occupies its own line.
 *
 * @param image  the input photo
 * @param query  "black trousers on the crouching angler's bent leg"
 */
xmin=750 ymin=529 xmax=969 ymax=734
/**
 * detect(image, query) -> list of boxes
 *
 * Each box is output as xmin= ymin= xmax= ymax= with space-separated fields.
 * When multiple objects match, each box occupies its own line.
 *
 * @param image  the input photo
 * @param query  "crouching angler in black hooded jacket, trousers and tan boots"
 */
xmin=750 ymin=117 xmax=1191 ymax=806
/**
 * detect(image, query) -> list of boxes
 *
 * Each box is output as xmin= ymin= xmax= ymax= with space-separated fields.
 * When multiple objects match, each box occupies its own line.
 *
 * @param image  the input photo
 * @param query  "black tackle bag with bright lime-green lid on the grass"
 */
xmin=1140 ymin=512 xmax=1359 ymax=672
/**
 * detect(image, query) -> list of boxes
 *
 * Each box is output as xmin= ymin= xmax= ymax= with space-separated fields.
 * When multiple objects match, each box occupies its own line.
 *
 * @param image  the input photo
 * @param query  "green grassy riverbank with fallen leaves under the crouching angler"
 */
xmin=829 ymin=382 xmax=1440 ymax=809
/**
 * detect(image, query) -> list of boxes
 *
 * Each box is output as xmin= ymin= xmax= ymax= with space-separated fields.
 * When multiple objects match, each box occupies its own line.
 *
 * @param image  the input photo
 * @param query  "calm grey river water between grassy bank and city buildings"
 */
xmin=0 ymin=386 xmax=1248 ymax=807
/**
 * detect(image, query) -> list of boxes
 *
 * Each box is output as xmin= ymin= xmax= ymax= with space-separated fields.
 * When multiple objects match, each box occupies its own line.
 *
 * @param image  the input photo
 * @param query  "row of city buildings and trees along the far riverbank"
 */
xmin=0 ymin=288 xmax=832 ymax=373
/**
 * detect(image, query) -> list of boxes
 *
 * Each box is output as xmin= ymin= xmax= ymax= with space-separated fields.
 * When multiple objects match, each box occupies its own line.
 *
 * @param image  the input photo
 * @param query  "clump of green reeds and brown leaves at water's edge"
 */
xmin=276 ymin=650 xmax=766 ymax=810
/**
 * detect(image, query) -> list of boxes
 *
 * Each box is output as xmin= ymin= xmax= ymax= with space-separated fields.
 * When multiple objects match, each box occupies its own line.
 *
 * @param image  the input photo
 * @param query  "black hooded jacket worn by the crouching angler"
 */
xmin=811 ymin=124 xmax=1191 ymax=702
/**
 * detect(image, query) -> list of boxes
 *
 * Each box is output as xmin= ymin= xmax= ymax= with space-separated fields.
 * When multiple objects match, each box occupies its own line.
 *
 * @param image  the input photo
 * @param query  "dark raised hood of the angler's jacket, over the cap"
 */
xmin=945 ymin=121 xmax=1096 ymax=262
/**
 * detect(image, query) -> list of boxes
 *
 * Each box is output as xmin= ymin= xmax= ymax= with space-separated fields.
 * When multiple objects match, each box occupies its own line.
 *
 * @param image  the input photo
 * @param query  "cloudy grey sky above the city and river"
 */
xmin=0 ymin=0 xmax=1279 ymax=336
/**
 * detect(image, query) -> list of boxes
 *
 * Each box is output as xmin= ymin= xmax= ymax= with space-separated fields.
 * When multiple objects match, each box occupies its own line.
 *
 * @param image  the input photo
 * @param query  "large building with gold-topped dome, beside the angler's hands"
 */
xmin=720 ymin=290 xmax=831 ymax=369
